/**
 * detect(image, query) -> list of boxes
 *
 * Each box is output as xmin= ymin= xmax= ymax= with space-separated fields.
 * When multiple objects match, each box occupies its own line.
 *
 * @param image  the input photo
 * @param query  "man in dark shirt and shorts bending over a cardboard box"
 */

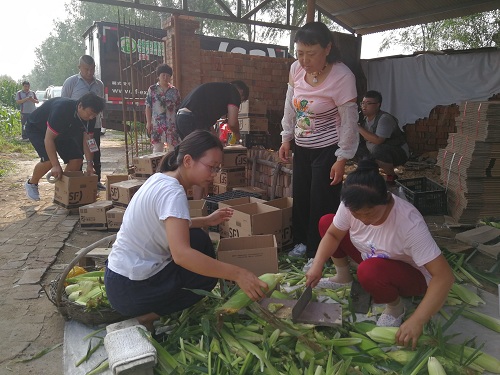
xmin=24 ymin=92 xmax=104 ymax=201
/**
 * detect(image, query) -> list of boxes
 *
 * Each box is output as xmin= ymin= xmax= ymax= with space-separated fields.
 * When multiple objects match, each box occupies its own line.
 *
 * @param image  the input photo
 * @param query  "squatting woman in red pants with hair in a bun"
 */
xmin=306 ymin=159 xmax=454 ymax=348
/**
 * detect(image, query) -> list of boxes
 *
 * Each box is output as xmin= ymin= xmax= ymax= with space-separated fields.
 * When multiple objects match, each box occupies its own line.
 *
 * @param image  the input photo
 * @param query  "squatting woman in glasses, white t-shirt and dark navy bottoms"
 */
xmin=104 ymin=130 xmax=267 ymax=330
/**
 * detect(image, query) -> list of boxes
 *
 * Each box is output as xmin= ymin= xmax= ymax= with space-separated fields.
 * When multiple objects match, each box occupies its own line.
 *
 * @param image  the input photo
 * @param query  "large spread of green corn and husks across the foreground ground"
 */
xmin=146 ymin=271 xmax=500 ymax=375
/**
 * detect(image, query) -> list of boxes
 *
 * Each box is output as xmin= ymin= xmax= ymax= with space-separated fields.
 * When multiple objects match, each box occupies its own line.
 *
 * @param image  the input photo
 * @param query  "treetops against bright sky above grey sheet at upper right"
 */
xmin=379 ymin=10 xmax=500 ymax=52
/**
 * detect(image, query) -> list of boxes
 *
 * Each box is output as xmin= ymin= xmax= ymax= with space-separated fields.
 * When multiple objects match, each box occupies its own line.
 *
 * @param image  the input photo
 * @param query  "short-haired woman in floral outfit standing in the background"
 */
xmin=146 ymin=64 xmax=181 ymax=152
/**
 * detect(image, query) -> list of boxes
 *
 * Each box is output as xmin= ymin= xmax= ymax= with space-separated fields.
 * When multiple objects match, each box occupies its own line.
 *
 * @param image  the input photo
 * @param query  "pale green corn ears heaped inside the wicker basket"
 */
xmin=64 ymin=266 xmax=111 ymax=311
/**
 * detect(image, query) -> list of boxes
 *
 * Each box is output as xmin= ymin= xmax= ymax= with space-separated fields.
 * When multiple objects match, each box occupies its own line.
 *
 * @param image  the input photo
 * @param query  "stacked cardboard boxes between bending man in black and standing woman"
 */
xmin=238 ymin=99 xmax=269 ymax=148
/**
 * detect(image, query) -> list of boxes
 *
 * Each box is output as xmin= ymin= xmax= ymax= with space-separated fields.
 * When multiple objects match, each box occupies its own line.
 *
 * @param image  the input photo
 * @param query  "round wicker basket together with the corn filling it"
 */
xmin=47 ymin=234 xmax=126 ymax=325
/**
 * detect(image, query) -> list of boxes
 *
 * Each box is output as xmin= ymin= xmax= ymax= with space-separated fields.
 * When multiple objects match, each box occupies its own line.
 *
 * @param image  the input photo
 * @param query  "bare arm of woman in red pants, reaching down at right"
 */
xmin=396 ymin=255 xmax=455 ymax=349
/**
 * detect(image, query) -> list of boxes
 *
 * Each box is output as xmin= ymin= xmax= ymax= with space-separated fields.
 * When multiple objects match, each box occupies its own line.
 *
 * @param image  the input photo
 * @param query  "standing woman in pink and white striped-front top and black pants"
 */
xmin=279 ymin=22 xmax=359 ymax=271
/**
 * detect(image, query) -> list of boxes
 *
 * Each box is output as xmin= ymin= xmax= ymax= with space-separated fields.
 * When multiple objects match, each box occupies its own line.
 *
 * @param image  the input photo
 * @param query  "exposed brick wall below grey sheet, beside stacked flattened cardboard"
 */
xmin=404 ymin=104 xmax=459 ymax=155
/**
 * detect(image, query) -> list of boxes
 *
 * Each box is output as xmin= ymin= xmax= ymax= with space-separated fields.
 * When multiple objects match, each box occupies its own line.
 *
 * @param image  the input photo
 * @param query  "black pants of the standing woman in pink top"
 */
xmin=292 ymin=145 xmax=342 ymax=258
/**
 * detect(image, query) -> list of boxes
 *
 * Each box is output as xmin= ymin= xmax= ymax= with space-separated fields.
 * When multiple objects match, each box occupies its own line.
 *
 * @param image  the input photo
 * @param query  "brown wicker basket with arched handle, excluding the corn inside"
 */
xmin=47 ymin=234 xmax=128 ymax=326
